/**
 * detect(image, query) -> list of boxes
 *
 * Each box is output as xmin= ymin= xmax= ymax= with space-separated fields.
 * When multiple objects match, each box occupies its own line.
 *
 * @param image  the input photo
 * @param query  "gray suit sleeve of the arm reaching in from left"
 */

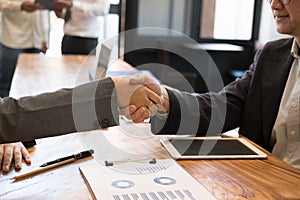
xmin=0 ymin=78 xmax=119 ymax=143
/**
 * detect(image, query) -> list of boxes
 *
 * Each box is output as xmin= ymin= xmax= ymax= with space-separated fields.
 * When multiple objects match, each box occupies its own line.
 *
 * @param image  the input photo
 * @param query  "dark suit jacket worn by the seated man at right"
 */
xmin=151 ymin=39 xmax=293 ymax=150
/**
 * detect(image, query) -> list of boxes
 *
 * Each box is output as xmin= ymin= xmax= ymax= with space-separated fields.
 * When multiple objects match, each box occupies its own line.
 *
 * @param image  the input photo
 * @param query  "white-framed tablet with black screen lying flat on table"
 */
xmin=160 ymin=137 xmax=267 ymax=159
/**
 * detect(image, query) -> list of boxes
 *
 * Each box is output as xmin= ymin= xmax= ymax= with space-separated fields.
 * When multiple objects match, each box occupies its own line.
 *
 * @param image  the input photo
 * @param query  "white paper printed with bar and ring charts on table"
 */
xmin=80 ymin=159 xmax=215 ymax=200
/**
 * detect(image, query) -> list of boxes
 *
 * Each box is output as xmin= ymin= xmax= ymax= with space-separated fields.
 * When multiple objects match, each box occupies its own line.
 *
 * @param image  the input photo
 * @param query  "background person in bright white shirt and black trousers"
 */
xmin=54 ymin=0 xmax=110 ymax=55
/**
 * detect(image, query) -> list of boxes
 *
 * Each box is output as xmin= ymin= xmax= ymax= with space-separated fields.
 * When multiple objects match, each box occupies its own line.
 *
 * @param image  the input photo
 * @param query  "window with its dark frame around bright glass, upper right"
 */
xmin=196 ymin=0 xmax=262 ymax=45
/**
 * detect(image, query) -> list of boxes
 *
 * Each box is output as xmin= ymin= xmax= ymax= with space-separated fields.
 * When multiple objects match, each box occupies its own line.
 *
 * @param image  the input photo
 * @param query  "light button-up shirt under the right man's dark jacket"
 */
xmin=271 ymin=40 xmax=300 ymax=169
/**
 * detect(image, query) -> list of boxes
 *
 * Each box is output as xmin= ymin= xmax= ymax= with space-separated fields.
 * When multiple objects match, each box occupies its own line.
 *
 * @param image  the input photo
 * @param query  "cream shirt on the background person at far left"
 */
xmin=0 ymin=0 xmax=50 ymax=49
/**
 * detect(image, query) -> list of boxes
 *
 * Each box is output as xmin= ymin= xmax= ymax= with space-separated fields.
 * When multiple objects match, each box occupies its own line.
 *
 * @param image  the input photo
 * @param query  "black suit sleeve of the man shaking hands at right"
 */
xmin=151 ymin=51 xmax=260 ymax=136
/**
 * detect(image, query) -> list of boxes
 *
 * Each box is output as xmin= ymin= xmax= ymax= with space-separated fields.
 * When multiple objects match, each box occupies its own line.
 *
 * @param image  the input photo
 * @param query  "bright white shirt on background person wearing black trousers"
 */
xmin=64 ymin=0 xmax=110 ymax=38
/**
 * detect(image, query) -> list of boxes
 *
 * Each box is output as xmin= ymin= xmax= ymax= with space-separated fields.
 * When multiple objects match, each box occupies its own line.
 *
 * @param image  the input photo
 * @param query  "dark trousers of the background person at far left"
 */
xmin=0 ymin=44 xmax=41 ymax=97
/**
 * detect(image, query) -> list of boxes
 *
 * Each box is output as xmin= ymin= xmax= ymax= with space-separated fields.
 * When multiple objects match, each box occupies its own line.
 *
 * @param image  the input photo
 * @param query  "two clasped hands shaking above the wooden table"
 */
xmin=112 ymin=74 xmax=169 ymax=123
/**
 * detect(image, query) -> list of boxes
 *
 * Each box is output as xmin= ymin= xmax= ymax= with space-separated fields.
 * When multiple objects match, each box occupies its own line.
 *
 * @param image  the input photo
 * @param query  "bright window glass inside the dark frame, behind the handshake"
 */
xmin=200 ymin=0 xmax=255 ymax=40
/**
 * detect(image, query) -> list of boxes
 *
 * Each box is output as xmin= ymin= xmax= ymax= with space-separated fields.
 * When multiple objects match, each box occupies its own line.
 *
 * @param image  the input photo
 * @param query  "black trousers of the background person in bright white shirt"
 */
xmin=61 ymin=35 xmax=98 ymax=55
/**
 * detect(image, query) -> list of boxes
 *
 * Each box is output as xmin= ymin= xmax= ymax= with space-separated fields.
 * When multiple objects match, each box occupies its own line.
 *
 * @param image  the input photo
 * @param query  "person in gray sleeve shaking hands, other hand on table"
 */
xmin=0 ymin=77 xmax=162 ymax=172
